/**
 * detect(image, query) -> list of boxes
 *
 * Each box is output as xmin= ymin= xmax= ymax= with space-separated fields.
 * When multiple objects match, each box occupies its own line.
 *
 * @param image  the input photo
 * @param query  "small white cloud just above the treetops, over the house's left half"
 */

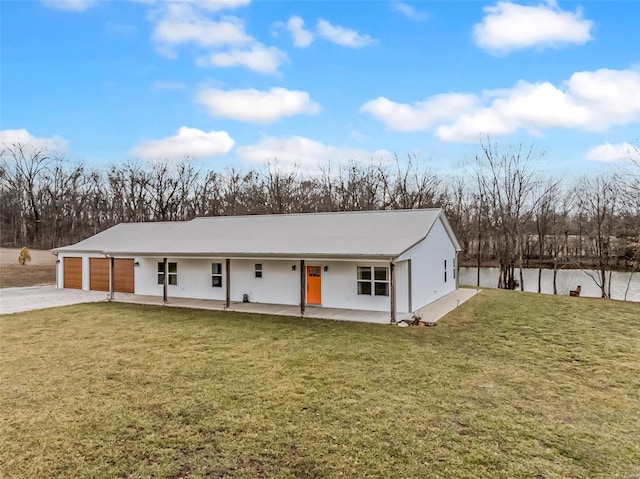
xmin=130 ymin=126 xmax=235 ymax=160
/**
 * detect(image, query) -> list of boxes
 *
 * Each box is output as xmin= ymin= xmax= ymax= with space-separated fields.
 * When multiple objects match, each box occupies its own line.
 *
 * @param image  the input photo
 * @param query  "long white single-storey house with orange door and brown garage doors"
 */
xmin=53 ymin=209 xmax=460 ymax=323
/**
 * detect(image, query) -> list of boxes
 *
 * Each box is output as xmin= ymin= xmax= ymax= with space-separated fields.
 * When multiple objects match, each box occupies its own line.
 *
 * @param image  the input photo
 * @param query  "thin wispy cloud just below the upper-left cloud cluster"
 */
xmin=196 ymin=43 xmax=287 ymax=74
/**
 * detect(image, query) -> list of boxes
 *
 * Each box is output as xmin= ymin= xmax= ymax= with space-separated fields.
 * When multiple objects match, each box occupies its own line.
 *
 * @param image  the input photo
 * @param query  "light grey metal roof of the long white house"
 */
xmin=54 ymin=208 xmax=459 ymax=258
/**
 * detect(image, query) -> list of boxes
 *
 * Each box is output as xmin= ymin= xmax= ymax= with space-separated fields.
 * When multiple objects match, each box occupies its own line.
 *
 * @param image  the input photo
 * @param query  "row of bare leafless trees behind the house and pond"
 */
xmin=0 ymin=138 xmax=640 ymax=296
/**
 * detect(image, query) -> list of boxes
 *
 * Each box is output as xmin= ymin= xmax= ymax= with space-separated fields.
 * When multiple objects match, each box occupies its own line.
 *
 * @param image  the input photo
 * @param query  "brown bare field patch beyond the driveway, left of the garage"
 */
xmin=0 ymin=248 xmax=56 ymax=288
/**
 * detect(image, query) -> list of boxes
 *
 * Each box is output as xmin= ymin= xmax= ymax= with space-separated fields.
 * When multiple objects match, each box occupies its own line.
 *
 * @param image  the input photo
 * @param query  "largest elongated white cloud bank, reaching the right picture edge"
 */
xmin=361 ymin=69 xmax=640 ymax=141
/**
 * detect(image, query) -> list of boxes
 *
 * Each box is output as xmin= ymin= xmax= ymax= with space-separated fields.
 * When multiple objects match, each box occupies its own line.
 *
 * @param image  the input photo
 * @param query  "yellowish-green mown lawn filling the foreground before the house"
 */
xmin=0 ymin=290 xmax=640 ymax=479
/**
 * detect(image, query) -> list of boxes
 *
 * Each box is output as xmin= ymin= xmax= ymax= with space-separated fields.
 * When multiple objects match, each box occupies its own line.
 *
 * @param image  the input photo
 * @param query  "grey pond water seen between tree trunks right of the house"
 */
xmin=460 ymin=268 xmax=640 ymax=302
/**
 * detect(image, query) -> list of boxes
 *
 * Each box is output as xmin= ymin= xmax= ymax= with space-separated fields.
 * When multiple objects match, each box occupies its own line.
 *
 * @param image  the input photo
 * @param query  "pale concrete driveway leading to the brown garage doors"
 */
xmin=0 ymin=286 xmax=107 ymax=314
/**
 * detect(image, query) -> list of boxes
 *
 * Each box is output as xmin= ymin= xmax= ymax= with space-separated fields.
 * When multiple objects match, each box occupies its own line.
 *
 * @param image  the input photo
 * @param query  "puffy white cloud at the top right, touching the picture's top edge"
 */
xmin=473 ymin=0 xmax=593 ymax=53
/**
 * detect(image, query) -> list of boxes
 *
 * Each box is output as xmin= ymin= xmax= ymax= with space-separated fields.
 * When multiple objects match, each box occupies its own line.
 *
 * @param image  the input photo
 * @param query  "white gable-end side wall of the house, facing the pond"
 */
xmin=399 ymin=219 xmax=456 ymax=311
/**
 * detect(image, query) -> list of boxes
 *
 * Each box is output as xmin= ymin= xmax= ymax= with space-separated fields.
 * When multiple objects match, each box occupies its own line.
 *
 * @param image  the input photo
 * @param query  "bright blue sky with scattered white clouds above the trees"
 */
xmin=0 ymin=0 xmax=640 ymax=173
